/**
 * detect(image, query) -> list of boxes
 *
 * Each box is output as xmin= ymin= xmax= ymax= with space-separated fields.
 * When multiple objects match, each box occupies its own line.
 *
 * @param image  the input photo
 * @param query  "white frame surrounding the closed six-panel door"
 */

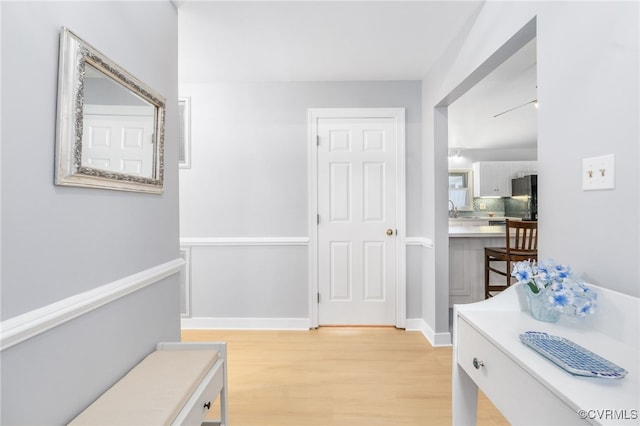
xmin=307 ymin=108 xmax=407 ymax=328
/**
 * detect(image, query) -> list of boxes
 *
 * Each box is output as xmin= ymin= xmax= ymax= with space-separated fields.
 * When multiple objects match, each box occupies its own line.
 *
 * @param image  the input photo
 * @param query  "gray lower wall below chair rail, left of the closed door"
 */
xmin=182 ymin=238 xmax=309 ymax=321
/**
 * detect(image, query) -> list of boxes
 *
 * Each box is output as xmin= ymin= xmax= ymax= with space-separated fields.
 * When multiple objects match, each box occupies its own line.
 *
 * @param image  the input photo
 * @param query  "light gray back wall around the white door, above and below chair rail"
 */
xmin=180 ymin=79 xmax=421 ymax=318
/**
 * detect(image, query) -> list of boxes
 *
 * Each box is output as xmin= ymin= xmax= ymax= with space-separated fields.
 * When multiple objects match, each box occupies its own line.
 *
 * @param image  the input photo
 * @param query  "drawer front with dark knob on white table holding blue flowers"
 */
xmin=456 ymin=318 xmax=586 ymax=425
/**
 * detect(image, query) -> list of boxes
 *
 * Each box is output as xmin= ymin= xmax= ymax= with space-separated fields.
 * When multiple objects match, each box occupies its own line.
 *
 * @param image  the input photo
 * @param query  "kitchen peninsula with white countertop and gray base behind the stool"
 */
xmin=449 ymin=225 xmax=505 ymax=307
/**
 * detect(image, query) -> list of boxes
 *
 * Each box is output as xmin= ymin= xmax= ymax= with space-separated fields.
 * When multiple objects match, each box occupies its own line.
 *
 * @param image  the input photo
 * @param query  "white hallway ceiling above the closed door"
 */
xmin=178 ymin=0 xmax=483 ymax=82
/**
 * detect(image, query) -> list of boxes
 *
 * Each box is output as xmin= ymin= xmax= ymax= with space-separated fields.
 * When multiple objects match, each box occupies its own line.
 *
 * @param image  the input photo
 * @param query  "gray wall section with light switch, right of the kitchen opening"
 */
xmin=538 ymin=2 xmax=640 ymax=288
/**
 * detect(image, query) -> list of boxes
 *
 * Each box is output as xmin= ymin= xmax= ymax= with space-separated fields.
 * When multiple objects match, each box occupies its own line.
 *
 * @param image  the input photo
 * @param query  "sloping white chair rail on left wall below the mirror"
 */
xmin=0 ymin=259 xmax=185 ymax=351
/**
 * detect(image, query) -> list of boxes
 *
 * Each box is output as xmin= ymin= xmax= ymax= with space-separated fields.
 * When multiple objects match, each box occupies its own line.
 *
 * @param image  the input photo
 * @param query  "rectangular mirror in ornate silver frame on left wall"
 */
xmin=55 ymin=28 xmax=166 ymax=193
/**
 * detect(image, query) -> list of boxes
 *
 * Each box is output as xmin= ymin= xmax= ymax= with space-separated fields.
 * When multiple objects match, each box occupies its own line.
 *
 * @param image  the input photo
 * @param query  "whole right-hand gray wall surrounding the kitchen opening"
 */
xmin=423 ymin=2 xmax=640 ymax=338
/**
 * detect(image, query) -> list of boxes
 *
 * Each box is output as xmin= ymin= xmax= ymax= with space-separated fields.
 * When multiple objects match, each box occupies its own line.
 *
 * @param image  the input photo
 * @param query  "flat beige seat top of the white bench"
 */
xmin=70 ymin=350 xmax=218 ymax=426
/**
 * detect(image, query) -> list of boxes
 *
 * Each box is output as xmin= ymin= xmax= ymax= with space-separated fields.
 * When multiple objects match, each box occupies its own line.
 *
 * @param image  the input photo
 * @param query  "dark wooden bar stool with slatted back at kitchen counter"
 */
xmin=484 ymin=219 xmax=538 ymax=299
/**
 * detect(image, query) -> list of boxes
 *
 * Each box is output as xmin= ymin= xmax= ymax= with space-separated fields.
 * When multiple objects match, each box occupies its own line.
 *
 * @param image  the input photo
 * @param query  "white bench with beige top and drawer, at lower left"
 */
xmin=69 ymin=342 xmax=227 ymax=426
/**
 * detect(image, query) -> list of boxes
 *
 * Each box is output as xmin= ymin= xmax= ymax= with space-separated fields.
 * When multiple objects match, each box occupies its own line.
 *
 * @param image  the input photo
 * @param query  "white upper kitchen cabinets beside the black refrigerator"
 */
xmin=472 ymin=161 xmax=537 ymax=197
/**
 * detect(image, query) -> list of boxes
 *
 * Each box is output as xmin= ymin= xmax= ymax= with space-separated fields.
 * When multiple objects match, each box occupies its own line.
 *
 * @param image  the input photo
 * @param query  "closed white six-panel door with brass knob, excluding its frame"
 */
xmin=317 ymin=117 xmax=399 ymax=325
